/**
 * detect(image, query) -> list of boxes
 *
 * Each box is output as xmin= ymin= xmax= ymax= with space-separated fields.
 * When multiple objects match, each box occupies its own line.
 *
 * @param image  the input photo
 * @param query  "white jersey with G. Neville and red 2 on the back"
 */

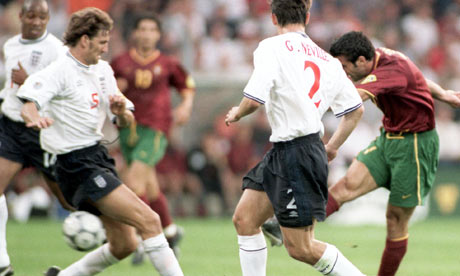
xmin=244 ymin=32 xmax=362 ymax=142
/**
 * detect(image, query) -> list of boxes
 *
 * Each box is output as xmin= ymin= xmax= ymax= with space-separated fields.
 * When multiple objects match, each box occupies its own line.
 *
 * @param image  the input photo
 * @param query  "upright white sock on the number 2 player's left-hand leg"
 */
xmin=238 ymin=232 xmax=267 ymax=276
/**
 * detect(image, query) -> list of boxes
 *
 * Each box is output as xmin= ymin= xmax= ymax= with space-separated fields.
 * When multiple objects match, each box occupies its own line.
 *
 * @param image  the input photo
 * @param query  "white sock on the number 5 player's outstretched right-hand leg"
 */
xmin=143 ymin=233 xmax=184 ymax=276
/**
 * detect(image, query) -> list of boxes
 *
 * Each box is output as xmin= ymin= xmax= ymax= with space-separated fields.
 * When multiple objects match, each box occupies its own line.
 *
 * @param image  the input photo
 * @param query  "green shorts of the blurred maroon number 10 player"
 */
xmin=120 ymin=125 xmax=168 ymax=167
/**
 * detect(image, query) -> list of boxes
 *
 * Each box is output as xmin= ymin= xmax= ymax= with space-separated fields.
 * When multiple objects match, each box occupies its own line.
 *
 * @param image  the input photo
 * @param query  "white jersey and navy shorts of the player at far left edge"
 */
xmin=0 ymin=32 xmax=65 ymax=180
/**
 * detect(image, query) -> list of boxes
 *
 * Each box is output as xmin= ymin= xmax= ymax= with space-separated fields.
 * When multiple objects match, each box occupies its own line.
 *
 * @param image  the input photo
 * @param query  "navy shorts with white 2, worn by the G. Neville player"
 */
xmin=243 ymin=133 xmax=328 ymax=227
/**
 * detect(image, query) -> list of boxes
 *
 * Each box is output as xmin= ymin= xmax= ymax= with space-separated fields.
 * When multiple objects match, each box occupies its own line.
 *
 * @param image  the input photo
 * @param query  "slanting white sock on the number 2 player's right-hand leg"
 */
xmin=313 ymin=243 xmax=364 ymax=276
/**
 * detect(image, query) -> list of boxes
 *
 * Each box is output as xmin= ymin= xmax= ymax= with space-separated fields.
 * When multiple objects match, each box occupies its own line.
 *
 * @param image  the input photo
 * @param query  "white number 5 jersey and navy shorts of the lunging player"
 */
xmin=18 ymin=52 xmax=134 ymax=212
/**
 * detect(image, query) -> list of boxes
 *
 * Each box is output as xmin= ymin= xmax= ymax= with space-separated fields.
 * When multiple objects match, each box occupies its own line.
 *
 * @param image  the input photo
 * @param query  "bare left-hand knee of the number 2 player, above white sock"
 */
xmin=233 ymin=189 xmax=274 ymax=235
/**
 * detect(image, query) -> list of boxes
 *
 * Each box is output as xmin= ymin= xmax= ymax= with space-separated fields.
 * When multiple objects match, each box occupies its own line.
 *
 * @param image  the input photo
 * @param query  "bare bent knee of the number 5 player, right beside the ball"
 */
xmin=100 ymin=215 xmax=138 ymax=259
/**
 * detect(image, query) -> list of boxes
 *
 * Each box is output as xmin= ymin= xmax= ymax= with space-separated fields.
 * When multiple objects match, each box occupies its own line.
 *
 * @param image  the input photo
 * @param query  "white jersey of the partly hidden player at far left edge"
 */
xmin=0 ymin=32 xmax=66 ymax=122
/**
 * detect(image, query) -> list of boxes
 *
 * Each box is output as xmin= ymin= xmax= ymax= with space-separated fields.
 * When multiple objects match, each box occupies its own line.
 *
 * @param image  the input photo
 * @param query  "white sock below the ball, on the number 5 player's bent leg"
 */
xmin=59 ymin=243 xmax=119 ymax=276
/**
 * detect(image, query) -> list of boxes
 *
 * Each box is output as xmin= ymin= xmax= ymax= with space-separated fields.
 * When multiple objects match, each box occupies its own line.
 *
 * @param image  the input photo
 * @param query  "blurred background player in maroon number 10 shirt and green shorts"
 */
xmin=112 ymin=15 xmax=195 ymax=258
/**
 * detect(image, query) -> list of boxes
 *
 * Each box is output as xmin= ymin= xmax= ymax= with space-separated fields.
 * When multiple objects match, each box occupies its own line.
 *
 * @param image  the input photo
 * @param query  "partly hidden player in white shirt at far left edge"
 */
xmin=0 ymin=0 xmax=70 ymax=276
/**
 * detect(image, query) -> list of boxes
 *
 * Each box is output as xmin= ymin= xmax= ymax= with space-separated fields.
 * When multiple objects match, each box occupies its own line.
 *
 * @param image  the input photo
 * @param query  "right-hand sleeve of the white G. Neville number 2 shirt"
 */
xmin=329 ymin=68 xmax=363 ymax=117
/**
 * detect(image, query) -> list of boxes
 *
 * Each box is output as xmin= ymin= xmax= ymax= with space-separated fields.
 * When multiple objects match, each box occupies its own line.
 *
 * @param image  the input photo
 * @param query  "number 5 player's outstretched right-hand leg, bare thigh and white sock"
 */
xmin=95 ymin=185 xmax=183 ymax=275
